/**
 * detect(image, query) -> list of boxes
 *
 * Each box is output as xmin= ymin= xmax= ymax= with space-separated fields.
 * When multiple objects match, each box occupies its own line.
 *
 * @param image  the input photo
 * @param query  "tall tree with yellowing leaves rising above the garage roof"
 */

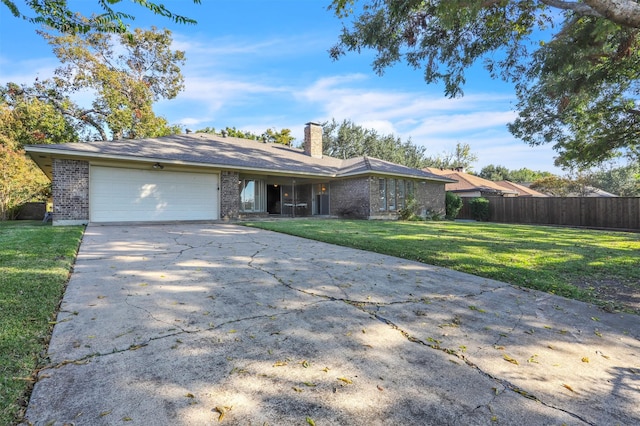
xmin=36 ymin=28 xmax=185 ymax=141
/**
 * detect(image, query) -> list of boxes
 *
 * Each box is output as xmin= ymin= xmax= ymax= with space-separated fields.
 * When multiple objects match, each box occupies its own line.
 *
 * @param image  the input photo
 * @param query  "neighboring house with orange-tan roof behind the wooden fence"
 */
xmin=423 ymin=167 xmax=518 ymax=198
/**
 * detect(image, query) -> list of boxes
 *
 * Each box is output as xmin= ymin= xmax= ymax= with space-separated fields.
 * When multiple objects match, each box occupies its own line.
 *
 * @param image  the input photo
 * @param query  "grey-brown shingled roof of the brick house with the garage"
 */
xmin=25 ymin=133 xmax=452 ymax=182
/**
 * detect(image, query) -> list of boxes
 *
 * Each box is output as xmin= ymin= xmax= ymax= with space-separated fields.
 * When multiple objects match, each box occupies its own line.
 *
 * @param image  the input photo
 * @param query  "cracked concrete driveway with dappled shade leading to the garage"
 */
xmin=26 ymin=224 xmax=640 ymax=426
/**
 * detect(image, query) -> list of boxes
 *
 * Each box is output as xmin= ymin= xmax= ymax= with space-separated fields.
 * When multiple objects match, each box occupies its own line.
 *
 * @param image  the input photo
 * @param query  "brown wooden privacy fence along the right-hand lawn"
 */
xmin=458 ymin=197 xmax=640 ymax=230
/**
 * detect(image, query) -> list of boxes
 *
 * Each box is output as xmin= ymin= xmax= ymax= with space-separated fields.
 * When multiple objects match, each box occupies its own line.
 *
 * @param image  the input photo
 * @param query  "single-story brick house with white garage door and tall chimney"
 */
xmin=25 ymin=123 xmax=453 ymax=225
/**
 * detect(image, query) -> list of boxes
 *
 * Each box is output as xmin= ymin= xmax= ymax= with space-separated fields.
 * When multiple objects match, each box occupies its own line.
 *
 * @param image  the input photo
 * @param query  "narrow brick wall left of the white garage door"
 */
xmin=51 ymin=158 xmax=89 ymax=225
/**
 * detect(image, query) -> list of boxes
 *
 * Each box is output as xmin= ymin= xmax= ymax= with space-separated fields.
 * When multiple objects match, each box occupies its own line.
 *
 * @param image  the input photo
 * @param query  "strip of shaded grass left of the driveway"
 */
xmin=0 ymin=221 xmax=84 ymax=425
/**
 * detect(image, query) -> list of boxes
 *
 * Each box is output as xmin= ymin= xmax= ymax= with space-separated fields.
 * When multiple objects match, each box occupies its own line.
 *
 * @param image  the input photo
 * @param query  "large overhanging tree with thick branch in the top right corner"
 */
xmin=330 ymin=0 xmax=640 ymax=167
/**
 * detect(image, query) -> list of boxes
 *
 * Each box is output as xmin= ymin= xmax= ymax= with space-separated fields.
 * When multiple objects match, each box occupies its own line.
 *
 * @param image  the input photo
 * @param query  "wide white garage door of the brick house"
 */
xmin=89 ymin=166 xmax=218 ymax=222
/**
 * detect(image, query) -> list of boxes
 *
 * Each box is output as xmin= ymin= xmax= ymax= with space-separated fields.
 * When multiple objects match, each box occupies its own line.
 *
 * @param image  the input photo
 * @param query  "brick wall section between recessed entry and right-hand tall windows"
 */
xmin=329 ymin=177 xmax=371 ymax=218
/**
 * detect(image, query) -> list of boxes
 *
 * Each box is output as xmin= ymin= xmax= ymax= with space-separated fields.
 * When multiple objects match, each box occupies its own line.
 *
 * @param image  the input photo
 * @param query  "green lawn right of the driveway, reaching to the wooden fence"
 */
xmin=247 ymin=219 xmax=640 ymax=313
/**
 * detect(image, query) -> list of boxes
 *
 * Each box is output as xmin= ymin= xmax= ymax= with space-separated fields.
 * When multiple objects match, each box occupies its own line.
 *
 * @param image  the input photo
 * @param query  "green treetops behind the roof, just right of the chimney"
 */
xmin=322 ymin=119 xmax=426 ymax=168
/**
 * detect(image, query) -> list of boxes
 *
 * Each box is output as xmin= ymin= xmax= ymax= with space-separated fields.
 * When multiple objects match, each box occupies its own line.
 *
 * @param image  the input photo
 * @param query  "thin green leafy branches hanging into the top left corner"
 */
xmin=1 ymin=0 xmax=201 ymax=34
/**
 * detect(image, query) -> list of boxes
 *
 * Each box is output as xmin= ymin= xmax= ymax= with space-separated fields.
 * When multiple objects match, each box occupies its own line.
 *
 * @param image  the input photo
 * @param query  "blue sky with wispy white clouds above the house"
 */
xmin=0 ymin=0 xmax=562 ymax=174
